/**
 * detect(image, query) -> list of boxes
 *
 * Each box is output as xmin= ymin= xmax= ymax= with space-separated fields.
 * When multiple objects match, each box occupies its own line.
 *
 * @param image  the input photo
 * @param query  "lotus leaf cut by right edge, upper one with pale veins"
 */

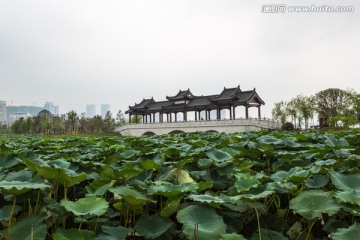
xmin=329 ymin=169 xmax=360 ymax=191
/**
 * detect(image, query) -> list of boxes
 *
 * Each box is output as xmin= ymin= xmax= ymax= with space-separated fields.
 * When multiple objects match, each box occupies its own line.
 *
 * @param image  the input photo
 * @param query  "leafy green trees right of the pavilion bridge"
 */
xmin=272 ymin=88 xmax=360 ymax=129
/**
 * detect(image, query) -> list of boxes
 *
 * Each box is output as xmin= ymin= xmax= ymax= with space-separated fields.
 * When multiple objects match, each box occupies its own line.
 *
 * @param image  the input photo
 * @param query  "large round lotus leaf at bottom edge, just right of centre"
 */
xmin=176 ymin=205 xmax=226 ymax=240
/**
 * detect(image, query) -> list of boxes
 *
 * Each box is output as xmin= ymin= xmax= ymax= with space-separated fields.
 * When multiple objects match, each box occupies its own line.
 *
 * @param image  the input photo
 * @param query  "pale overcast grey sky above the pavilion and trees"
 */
xmin=0 ymin=0 xmax=360 ymax=117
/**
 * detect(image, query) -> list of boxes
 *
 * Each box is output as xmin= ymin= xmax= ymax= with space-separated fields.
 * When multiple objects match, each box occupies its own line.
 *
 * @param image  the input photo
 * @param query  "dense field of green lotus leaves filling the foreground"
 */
xmin=0 ymin=131 xmax=360 ymax=240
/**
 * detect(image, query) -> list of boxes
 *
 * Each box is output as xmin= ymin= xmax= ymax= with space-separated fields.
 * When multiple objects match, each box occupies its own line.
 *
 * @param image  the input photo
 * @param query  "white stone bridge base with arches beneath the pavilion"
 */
xmin=115 ymin=118 xmax=280 ymax=136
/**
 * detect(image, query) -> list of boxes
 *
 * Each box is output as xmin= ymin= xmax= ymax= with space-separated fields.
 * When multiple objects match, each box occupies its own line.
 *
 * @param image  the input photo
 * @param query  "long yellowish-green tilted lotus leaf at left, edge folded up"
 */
xmin=23 ymin=159 xmax=87 ymax=187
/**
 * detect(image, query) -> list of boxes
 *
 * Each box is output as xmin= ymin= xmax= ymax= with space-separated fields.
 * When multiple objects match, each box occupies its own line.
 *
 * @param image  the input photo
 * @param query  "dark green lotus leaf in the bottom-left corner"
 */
xmin=0 ymin=214 xmax=47 ymax=240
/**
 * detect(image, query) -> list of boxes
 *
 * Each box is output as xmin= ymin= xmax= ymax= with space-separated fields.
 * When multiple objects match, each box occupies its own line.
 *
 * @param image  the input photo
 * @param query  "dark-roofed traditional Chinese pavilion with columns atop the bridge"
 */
xmin=125 ymin=86 xmax=265 ymax=123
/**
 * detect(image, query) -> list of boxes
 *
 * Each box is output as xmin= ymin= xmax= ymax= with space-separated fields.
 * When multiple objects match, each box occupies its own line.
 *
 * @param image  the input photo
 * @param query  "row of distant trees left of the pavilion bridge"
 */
xmin=11 ymin=110 xmax=126 ymax=134
